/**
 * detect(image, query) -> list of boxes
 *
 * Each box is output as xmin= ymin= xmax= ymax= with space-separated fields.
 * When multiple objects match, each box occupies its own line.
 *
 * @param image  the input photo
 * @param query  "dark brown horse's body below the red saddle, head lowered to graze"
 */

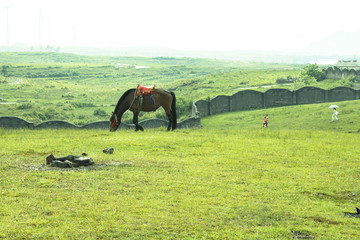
xmin=110 ymin=89 xmax=177 ymax=132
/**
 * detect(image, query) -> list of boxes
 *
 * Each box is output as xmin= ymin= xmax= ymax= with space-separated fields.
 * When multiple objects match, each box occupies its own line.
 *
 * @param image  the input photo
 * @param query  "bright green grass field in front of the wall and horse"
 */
xmin=0 ymin=101 xmax=360 ymax=239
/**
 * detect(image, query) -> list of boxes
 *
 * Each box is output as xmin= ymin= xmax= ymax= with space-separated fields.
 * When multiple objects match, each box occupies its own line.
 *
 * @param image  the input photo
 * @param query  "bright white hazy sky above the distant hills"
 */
xmin=0 ymin=0 xmax=360 ymax=51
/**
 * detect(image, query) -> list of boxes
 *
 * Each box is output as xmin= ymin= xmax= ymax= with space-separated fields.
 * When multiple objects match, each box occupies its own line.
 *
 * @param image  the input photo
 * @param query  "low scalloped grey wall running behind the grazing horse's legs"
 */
xmin=0 ymin=117 xmax=201 ymax=130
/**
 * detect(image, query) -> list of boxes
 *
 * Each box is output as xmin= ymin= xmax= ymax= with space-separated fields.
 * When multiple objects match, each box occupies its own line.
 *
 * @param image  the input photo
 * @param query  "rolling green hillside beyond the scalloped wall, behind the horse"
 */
xmin=0 ymin=52 xmax=299 ymax=125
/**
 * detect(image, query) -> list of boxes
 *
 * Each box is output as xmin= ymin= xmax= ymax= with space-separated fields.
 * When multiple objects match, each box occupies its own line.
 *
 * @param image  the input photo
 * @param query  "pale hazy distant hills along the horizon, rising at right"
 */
xmin=0 ymin=31 xmax=360 ymax=64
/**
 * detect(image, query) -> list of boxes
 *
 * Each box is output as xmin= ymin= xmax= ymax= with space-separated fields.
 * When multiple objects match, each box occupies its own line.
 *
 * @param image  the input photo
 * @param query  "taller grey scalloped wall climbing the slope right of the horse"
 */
xmin=193 ymin=87 xmax=360 ymax=117
